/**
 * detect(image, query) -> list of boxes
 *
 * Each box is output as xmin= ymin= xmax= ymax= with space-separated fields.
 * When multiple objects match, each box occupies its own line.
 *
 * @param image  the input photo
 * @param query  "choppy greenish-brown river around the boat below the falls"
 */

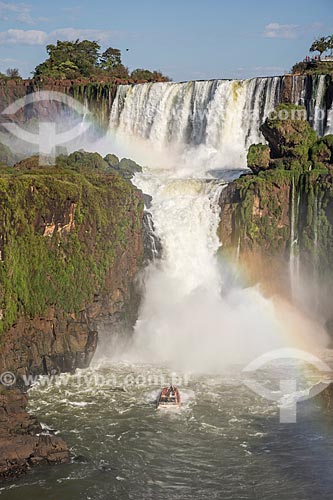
xmin=0 ymin=362 xmax=333 ymax=500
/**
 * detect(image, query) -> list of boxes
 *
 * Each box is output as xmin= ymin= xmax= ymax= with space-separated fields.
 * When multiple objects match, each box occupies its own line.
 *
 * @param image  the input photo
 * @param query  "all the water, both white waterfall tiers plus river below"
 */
xmin=0 ymin=77 xmax=333 ymax=500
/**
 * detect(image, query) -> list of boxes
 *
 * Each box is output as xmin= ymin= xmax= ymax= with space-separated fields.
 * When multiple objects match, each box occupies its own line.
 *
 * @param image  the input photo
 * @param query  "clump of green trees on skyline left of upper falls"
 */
xmin=34 ymin=40 xmax=169 ymax=81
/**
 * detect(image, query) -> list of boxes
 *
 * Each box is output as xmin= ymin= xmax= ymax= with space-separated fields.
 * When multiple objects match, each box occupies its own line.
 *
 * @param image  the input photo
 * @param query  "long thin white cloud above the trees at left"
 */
xmin=0 ymin=28 xmax=117 ymax=45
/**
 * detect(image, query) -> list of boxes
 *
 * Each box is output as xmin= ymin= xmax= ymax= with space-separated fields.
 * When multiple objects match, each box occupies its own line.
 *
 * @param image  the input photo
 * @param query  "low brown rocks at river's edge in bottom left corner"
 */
xmin=0 ymin=389 xmax=69 ymax=480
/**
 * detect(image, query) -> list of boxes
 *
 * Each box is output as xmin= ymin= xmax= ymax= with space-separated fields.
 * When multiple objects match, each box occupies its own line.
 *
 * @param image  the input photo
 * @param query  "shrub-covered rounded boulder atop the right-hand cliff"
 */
xmin=260 ymin=104 xmax=317 ymax=162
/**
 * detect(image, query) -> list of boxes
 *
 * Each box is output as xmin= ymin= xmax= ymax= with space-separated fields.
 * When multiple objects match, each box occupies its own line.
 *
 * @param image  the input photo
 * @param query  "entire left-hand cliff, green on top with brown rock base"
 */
xmin=0 ymin=161 xmax=144 ymax=378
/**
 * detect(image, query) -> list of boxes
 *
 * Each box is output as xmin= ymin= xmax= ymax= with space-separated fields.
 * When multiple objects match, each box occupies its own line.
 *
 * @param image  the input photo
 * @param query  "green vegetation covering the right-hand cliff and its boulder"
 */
xmin=232 ymin=104 xmax=333 ymax=258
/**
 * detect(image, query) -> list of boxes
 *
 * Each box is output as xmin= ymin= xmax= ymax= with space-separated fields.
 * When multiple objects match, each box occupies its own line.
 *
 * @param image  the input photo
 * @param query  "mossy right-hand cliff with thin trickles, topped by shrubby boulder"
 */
xmin=219 ymin=104 xmax=333 ymax=322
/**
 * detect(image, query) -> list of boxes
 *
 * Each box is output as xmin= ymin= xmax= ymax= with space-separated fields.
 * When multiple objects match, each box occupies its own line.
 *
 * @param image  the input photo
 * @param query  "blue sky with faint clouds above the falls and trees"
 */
xmin=0 ymin=0 xmax=333 ymax=81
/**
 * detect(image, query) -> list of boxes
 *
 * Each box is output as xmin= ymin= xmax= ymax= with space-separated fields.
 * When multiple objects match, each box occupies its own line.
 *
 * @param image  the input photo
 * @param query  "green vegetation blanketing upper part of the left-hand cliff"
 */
xmin=0 ymin=152 xmax=143 ymax=332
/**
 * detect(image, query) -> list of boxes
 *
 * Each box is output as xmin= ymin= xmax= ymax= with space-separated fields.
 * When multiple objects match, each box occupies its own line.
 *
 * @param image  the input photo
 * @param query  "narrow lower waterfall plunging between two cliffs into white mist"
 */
xmin=126 ymin=167 xmax=290 ymax=371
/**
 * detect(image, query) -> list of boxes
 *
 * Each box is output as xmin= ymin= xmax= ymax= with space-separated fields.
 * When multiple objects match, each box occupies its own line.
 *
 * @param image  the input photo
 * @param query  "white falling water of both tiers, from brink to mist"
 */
xmin=104 ymin=77 xmax=326 ymax=370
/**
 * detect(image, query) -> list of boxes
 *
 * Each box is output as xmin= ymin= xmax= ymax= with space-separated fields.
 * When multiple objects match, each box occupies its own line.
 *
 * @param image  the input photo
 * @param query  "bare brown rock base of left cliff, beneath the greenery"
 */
xmin=0 ymin=307 xmax=97 ymax=380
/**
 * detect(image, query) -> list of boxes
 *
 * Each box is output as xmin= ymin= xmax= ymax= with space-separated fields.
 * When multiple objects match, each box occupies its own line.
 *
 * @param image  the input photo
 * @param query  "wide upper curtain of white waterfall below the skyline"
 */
xmin=110 ymin=77 xmax=301 ymax=170
